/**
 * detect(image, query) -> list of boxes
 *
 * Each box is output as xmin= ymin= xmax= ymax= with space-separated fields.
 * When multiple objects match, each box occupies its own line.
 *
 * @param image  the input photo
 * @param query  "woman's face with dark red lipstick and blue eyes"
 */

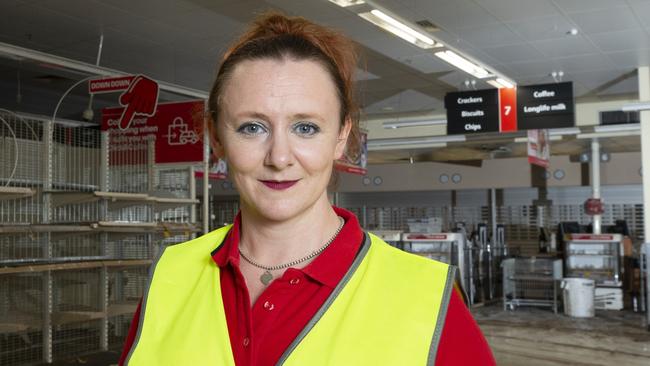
xmin=217 ymin=59 xmax=350 ymax=221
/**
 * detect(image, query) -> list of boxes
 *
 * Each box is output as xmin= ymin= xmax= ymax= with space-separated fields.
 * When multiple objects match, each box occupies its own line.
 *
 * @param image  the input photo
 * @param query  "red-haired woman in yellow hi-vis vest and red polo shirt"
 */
xmin=121 ymin=13 xmax=494 ymax=365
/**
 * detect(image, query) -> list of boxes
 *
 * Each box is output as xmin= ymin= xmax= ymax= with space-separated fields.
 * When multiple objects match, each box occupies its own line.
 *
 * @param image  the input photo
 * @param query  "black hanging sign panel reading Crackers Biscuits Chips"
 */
xmin=445 ymin=89 xmax=499 ymax=135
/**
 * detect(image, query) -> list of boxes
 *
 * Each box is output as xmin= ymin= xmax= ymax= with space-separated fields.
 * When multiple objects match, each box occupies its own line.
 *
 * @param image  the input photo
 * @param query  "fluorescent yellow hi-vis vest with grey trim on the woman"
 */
xmin=126 ymin=227 xmax=454 ymax=366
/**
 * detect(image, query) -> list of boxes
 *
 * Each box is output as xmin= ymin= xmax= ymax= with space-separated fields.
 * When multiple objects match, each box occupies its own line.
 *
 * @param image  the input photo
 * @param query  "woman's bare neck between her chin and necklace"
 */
xmin=240 ymin=200 xmax=340 ymax=266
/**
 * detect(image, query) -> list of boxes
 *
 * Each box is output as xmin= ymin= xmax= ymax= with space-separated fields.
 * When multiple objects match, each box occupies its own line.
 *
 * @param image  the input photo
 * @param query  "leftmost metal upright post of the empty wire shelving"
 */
xmin=41 ymin=120 xmax=54 ymax=363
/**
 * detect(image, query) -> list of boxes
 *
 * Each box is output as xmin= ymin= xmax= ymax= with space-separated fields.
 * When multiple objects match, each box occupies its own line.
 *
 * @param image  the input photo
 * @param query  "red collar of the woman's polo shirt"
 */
xmin=212 ymin=206 xmax=363 ymax=288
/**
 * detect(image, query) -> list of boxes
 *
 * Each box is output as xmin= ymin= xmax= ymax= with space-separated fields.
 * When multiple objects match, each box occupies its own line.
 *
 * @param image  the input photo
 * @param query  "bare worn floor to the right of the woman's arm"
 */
xmin=472 ymin=304 xmax=650 ymax=366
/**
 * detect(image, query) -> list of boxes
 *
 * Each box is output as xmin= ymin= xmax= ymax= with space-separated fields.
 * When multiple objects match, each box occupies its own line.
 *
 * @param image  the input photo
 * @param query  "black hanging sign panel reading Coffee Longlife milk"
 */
xmin=517 ymin=82 xmax=575 ymax=130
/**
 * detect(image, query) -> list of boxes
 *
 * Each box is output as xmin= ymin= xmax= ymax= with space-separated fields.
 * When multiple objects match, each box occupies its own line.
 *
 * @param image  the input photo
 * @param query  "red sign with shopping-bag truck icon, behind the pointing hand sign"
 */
xmin=101 ymin=100 xmax=204 ymax=165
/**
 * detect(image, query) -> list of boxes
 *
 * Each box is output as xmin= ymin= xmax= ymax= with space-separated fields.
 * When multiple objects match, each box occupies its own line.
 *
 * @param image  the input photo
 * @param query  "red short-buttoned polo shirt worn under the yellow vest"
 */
xmin=120 ymin=207 xmax=495 ymax=366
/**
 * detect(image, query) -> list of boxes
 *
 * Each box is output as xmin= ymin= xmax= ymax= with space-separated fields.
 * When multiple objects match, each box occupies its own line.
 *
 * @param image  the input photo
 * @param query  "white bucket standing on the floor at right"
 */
xmin=562 ymin=278 xmax=596 ymax=318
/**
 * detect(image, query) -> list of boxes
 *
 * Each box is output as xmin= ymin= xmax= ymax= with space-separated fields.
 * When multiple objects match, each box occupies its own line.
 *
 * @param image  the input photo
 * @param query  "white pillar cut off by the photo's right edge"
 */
xmin=638 ymin=66 xmax=650 ymax=243
